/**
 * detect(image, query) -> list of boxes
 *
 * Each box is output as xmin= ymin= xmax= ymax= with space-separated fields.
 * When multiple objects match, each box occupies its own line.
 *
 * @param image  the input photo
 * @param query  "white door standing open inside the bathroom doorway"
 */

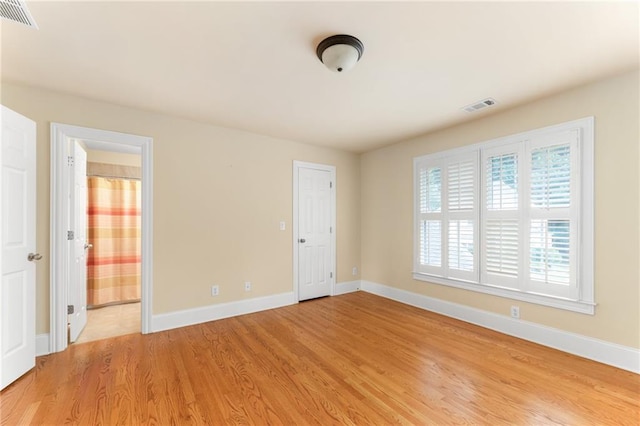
xmin=67 ymin=140 xmax=89 ymax=342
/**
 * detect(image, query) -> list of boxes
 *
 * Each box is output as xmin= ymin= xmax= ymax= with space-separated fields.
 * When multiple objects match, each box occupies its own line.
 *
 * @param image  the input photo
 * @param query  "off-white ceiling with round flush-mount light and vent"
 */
xmin=1 ymin=1 xmax=640 ymax=152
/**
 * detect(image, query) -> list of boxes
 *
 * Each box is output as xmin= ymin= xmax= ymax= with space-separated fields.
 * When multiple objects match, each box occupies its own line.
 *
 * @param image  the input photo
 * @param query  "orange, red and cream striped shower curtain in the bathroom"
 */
xmin=87 ymin=176 xmax=141 ymax=306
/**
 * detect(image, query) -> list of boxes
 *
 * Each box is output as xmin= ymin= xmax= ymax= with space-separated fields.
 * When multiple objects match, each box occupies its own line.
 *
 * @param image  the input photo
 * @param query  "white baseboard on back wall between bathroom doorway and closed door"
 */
xmin=151 ymin=292 xmax=297 ymax=332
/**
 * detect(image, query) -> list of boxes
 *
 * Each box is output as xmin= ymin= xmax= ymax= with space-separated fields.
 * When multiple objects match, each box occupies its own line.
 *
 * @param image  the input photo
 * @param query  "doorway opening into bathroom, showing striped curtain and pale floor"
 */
xmin=74 ymin=149 xmax=142 ymax=343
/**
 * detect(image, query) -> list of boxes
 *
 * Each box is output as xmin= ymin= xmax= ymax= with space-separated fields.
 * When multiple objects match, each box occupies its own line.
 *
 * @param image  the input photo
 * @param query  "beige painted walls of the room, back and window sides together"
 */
xmin=1 ymin=71 xmax=640 ymax=348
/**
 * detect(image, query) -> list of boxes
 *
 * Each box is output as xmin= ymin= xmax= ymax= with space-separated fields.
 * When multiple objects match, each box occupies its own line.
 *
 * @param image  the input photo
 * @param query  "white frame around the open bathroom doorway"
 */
xmin=49 ymin=123 xmax=153 ymax=353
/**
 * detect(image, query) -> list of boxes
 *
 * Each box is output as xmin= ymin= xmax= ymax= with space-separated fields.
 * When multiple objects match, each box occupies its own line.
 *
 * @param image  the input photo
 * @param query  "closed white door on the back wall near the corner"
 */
xmin=298 ymin=168 xmax=333 ymax=300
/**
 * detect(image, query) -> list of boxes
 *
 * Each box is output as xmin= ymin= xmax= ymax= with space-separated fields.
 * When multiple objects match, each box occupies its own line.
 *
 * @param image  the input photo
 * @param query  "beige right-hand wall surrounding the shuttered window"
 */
xmin=361 ymin=71 xmax=640 ymax=348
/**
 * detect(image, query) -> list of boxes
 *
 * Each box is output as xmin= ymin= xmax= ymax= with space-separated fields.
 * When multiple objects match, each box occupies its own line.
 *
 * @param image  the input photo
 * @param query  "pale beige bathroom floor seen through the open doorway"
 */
xmin=76 ymin=302 xmax=141 ymax=344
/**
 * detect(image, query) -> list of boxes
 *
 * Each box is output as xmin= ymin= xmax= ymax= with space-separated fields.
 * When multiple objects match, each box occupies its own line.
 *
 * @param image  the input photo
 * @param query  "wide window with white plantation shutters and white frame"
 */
xmin=414 ymin=118 xmax=594 ymax=314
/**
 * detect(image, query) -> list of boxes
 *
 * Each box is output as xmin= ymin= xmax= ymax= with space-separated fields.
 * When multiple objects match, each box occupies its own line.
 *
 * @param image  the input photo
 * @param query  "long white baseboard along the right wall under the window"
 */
xmin=360 ymin=280 xmax=640 ymax=374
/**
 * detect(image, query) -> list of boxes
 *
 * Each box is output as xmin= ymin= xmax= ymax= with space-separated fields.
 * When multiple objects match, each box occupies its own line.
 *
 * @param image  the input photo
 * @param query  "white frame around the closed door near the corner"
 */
xmin=293 ymin=160 xmax=337 ymax=303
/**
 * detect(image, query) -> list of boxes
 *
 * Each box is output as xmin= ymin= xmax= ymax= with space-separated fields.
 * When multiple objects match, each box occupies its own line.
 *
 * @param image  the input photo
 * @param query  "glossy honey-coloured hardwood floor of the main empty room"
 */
xmin=0 ymin=292 xmax=640 ymax=425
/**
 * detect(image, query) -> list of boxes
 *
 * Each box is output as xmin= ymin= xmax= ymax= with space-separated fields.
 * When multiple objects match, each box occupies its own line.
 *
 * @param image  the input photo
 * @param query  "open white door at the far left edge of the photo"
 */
xmin=0 ymin=106 xmax=41 ymax=389
